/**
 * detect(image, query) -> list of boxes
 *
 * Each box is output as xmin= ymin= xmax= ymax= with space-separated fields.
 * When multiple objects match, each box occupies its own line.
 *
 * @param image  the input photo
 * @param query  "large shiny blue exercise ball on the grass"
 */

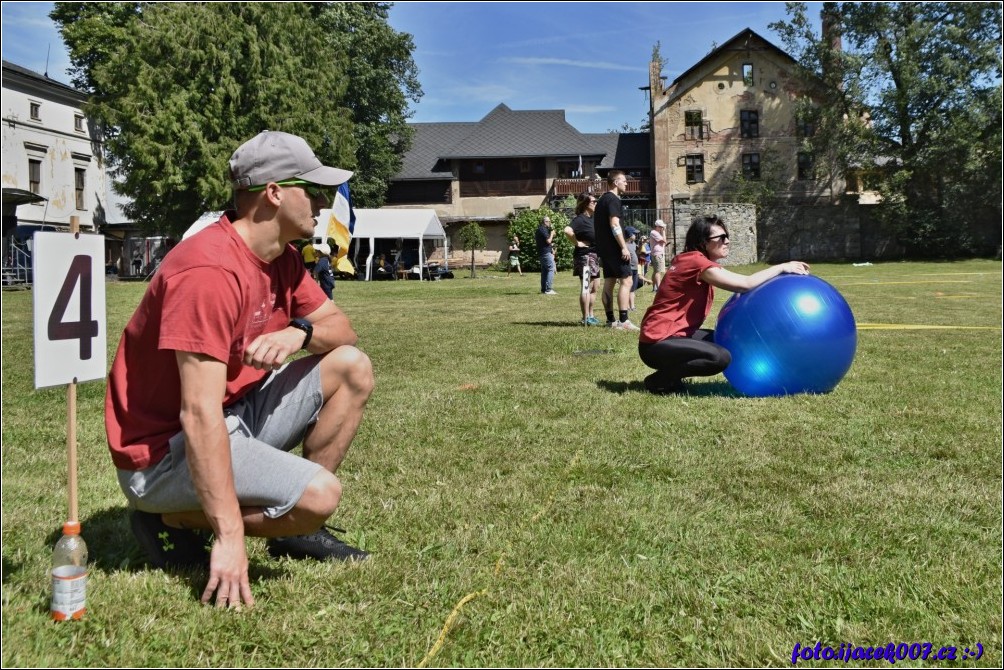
xmin=715 ymin=274 xmax=857 ymax=397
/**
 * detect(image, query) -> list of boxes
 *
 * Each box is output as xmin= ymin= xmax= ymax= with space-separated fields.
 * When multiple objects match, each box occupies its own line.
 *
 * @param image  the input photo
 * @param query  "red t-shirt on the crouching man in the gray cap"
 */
xmin=104 ymin=212 xmax=327 ymax=470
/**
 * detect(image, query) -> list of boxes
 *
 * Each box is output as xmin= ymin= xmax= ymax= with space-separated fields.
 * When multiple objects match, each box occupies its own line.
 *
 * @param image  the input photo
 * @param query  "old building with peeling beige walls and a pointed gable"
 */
xmin=650 ymin=28 xmax=844 ymax=209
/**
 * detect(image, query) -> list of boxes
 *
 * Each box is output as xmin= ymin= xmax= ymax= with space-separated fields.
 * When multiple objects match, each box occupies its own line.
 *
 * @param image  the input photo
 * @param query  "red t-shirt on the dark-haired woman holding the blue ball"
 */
xmin=639 ymin=251 xmax=721 ymax=344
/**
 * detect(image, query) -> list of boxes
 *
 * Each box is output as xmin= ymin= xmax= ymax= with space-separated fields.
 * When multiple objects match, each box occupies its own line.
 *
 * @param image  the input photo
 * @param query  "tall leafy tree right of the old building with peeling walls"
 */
xmin=770 ymin=2 xmax=1002 ymax=256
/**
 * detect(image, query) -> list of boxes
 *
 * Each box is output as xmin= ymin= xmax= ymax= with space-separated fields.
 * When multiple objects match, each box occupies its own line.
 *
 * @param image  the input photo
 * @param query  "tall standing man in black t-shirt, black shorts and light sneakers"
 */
xmin=592 ymin=170 xmax=639 ymax=330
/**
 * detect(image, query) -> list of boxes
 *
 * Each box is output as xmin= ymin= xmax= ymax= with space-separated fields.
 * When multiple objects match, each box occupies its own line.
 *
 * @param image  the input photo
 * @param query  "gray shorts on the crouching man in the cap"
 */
xmin=118 ymin=356 xmax=323 ymax=518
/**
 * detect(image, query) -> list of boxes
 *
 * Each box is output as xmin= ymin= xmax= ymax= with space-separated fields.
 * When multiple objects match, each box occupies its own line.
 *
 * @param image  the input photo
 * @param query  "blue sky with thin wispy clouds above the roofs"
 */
xmin=2 ymin=2 xmax=822 ymax=133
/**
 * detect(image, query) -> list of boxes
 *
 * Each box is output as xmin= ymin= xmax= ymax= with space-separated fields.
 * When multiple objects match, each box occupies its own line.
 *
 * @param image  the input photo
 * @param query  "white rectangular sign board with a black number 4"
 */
xmin=32 ymin=233 xmax=107 ymax=389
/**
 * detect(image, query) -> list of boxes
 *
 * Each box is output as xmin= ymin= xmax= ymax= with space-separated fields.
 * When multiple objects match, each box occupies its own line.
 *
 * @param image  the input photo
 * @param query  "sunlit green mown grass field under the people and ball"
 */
xmin=2 ymin=260 xmax=1004 ymax=667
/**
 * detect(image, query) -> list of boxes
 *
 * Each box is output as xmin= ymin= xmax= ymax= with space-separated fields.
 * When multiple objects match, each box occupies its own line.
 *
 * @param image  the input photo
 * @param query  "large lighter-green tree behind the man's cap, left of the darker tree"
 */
xmin=50 ymin=2 xmax=419 ymax=233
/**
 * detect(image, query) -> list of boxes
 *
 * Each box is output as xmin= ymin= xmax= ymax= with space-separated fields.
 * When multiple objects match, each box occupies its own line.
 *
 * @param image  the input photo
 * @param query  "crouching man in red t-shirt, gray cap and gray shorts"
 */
xmin=105 ymin=131 xmax=373 ymax=608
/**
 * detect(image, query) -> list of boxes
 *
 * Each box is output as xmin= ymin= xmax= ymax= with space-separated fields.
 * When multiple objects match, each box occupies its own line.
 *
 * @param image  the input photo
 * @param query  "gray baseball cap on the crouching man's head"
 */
xmin=230 ymin=131 xmax=352 ymax=191
